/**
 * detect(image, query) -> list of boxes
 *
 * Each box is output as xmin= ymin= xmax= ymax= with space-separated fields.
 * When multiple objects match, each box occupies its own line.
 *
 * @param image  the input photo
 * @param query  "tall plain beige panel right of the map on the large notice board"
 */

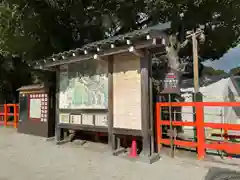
xmin=113 ymin=53 xmax=142 ymax=131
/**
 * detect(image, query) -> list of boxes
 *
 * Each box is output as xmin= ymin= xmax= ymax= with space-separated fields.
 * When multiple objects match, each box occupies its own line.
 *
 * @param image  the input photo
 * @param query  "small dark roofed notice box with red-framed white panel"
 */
xmin=18 ymin=84 xmax=55 ymax=137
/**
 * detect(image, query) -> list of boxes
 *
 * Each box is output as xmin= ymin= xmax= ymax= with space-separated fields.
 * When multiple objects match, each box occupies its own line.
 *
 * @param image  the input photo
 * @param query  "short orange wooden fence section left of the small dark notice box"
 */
xmin=0 ymin=104 xmax=19 ymax=128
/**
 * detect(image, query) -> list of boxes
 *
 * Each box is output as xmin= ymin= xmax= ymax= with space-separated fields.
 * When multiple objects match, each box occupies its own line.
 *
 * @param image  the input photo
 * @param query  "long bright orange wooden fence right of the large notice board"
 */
xmin=156 ymin=102 xmax=240 ymax=159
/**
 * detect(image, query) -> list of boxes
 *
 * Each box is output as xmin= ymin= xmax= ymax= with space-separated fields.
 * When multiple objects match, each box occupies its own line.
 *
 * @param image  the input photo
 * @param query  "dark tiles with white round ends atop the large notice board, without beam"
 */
xmin=34 ymin=22 xmax=171 ymax=67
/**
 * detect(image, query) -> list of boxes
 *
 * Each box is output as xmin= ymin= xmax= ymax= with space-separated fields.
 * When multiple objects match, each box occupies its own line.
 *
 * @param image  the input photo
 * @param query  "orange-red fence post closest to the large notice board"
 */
xmin=156 ymin=103 xmax=162 ymax=153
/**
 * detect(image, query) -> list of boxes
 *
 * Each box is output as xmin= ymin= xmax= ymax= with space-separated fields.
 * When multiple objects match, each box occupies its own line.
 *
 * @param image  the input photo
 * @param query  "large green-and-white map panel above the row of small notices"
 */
xmin=59 ymin=60 xmax=108 ymax=109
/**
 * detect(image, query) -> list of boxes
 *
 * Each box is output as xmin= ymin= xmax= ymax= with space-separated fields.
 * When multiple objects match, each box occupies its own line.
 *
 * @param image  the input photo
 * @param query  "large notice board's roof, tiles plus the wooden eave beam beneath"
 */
xmin=33 ymin=22 xmax=171 ymax=69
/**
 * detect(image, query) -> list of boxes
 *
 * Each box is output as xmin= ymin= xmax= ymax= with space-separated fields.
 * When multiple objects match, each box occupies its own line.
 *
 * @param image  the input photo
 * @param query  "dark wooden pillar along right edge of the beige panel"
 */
xmin=140 ymin=50 xmax=151 ymax=156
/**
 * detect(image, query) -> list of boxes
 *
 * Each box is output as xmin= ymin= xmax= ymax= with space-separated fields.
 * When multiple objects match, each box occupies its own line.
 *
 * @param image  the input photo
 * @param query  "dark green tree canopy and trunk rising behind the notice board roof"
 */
xmin=0 ymin=0 xmax=240 ymax=101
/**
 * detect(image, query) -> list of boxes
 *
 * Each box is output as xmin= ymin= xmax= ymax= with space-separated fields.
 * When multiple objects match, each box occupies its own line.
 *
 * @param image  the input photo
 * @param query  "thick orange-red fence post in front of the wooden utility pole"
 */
xmin=196 ymin=102 xmax=205 ymax=160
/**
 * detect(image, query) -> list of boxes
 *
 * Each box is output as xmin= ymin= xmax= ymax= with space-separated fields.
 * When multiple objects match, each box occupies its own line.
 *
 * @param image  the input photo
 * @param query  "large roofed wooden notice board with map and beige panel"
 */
xmin=35 ymin=23 xmax=171 ymax=162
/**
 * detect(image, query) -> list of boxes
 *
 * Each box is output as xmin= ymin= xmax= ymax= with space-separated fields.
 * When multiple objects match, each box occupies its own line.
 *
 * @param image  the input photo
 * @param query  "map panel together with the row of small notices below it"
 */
xmin=58 ymin=59 xmax=108 ymax=132
